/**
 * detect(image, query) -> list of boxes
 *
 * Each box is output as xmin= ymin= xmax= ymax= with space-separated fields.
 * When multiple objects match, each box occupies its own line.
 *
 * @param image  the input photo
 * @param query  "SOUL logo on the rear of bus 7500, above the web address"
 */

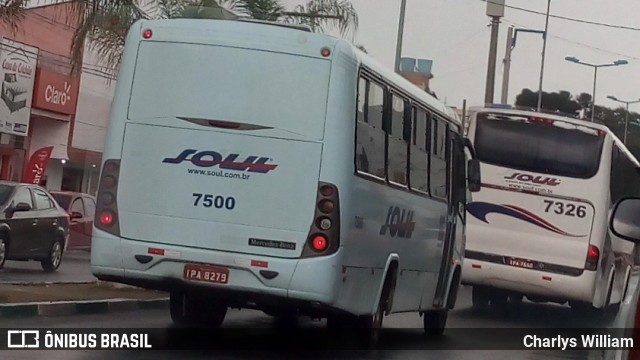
xmin=162 ymin=149 xmax=278 ymax=173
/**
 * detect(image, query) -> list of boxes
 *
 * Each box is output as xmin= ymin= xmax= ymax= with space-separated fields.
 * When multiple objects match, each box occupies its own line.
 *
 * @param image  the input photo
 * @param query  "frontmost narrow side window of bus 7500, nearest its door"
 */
xmin=429 ymin=118 xmax=447 ymax=199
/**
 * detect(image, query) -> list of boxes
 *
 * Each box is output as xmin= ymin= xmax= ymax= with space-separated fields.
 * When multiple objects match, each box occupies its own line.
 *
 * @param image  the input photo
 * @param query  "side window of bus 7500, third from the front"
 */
xmin=388 ymin=95 xmax=411 ymax=185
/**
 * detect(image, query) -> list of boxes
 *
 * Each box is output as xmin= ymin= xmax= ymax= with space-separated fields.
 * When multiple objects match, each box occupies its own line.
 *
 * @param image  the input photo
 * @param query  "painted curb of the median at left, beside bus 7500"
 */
xmin=0 ymin=298 xmax=169 ymax=319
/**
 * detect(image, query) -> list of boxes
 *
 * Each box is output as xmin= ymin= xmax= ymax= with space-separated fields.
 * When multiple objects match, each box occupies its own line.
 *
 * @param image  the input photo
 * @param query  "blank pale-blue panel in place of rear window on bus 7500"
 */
xmin=128 ymin=42 xmax=331 ymax=139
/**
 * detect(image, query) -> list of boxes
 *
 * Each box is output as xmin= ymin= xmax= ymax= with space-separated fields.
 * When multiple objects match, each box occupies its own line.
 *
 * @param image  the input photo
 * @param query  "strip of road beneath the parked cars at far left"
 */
xmin=0 ymin=251 xmax=96 ymax=283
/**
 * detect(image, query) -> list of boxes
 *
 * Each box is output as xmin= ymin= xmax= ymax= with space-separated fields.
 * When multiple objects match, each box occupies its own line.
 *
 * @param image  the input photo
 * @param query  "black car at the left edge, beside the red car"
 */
xmin=0 ymin=181 xmax=69 ymax=272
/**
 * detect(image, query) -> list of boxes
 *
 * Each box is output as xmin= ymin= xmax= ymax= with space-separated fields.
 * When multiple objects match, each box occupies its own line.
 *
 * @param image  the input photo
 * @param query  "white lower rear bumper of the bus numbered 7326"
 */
xmin=462 ymin=259 xmax=596 ymax=302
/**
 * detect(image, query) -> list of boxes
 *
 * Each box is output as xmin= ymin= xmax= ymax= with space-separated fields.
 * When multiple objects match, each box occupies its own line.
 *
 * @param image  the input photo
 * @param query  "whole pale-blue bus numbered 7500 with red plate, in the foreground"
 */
xmin=91 ymin=19 xmax=479 ymax=333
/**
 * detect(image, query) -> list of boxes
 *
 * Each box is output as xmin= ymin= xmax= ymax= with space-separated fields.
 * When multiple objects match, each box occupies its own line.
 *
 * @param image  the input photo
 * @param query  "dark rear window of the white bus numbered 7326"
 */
xmin=474 ymin=113 xmax=604 ymax=179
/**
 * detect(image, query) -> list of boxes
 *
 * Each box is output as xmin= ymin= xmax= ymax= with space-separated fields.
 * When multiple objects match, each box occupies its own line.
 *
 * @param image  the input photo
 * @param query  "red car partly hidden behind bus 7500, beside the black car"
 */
xmin=49 ymin=191 xmax=96 ymax=250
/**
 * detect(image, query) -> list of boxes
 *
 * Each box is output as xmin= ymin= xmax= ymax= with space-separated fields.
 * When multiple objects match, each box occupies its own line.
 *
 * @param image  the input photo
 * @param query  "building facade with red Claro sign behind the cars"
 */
xmin=0 ymin=3 xmax=115 ymax=194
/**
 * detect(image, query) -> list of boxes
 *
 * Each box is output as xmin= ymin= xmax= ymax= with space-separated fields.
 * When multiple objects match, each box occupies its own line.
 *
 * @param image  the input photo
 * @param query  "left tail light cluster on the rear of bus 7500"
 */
xmin=94 ymin=159 xmax=120 ymax=236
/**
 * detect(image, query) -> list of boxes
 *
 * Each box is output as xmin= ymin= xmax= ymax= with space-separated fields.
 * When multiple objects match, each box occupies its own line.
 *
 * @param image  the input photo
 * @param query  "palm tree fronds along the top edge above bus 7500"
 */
xmin=16 ymin=0 xmax=358 ymax=73
